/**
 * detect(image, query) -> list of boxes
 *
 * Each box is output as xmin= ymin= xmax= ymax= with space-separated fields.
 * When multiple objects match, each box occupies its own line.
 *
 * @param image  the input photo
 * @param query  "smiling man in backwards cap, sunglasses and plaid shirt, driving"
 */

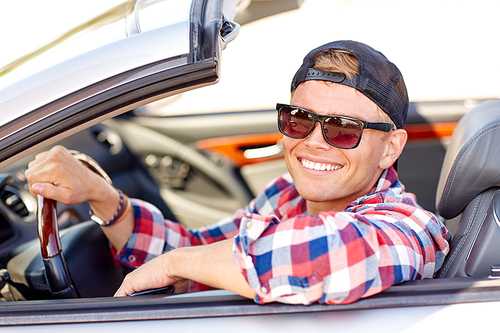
xmin=26 ymin=41 xmax=449 ymax=304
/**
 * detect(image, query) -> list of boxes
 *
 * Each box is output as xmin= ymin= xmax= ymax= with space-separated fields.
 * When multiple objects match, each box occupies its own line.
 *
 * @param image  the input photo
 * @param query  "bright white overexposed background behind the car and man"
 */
xmin=0 ymin=0 xmax=500 ymax=111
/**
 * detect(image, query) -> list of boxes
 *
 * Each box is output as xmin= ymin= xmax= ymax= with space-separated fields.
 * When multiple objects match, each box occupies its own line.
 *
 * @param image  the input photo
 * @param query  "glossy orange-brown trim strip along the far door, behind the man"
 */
xmin=196 ymin=122 xmax=457 ymax=167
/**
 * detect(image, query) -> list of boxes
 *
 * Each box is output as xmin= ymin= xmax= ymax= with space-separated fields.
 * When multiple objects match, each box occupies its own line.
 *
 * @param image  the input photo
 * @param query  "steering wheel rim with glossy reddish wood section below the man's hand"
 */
xmin=37 ymin=151 xmax=111 ymax=298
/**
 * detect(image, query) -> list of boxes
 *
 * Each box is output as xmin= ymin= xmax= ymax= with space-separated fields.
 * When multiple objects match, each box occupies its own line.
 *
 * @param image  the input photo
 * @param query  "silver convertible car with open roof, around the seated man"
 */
xmin=0 ymin=0 xmax=500 ymax=332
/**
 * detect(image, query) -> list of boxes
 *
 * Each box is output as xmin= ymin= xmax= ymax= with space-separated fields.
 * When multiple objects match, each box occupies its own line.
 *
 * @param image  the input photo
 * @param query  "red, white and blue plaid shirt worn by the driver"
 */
xmin=116 ymin=168 xmax=450 ymax=304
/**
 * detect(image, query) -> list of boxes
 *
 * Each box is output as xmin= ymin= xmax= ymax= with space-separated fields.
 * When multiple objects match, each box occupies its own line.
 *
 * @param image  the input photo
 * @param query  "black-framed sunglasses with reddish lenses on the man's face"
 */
xmin=276 ymin=104 xmax=393 ymax=149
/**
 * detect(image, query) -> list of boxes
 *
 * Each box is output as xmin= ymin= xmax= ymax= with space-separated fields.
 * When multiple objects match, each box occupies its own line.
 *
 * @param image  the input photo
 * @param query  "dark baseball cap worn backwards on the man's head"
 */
xmin=291 ymin=41 xmax=409 ymax=128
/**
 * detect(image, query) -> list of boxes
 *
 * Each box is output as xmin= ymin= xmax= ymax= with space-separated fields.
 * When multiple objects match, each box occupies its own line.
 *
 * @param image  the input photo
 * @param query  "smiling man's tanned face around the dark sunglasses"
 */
xmin=283 ymin=81 xmax=390 ymax=214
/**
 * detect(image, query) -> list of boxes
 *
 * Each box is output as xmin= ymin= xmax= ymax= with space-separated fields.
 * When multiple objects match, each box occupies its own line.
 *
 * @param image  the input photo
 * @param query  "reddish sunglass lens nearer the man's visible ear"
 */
xmin=325 ymin=117 xmax=361 ymax=148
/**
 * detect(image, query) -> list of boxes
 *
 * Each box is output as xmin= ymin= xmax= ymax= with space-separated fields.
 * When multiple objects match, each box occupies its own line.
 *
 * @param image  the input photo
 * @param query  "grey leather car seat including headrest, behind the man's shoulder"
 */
xmin=436 ymin=100 xmax=500 ymax=278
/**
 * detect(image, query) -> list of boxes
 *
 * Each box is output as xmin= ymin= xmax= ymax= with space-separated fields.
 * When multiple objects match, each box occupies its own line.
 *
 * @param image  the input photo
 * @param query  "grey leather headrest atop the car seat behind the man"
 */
xmin=436 ymin=100 xmax=500 ymax=219
